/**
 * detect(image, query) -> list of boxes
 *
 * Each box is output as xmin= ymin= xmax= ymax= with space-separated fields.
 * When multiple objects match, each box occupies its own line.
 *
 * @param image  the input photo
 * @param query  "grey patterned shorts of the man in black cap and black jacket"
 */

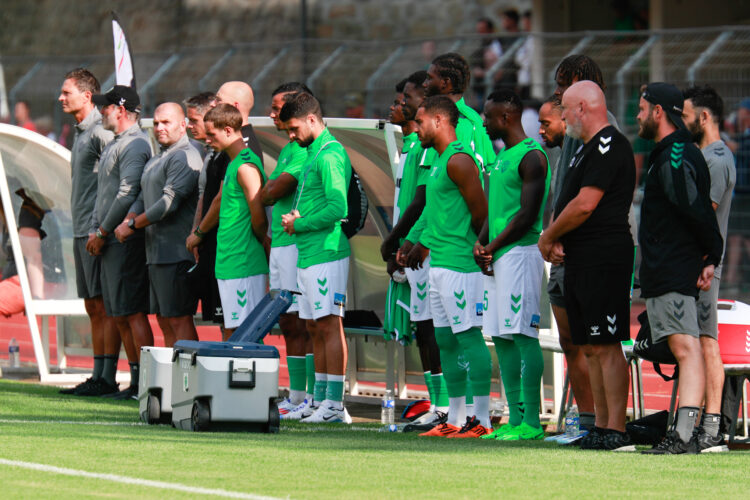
xmin=646 ymin=292 xmax=698 ymax=342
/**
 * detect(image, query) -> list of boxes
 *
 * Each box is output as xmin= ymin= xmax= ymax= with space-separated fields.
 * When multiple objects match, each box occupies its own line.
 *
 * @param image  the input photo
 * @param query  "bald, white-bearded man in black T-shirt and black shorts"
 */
xmin=539 ymin=81 xmax=635 ymax=451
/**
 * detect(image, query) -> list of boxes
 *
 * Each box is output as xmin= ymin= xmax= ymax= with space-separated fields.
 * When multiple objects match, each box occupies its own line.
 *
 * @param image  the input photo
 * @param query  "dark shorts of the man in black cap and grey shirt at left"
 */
xmin=101 ymin=234 xmax=148 ymax=316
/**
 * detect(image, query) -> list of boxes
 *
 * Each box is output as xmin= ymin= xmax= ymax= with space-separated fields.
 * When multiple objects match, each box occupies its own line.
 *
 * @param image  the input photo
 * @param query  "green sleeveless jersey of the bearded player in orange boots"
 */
xmin=418 ymin=140 xmax=482 ymax=273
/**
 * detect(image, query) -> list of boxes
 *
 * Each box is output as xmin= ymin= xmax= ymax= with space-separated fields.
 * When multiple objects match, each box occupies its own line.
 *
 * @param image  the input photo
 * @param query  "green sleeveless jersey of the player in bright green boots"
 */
xmin=488 ymin=138 xmax=550 ymax=259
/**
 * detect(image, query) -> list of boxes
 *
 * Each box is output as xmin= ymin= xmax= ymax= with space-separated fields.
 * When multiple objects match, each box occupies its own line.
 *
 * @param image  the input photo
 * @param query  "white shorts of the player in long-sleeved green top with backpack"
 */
xmin=297 ymin=257 xmax=349 ymax=319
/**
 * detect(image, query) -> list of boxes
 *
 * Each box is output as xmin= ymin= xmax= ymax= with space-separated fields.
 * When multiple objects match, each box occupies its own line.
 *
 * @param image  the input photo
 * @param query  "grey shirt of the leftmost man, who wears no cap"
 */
xmin=70 ymin=108 xmax=115 ymax=238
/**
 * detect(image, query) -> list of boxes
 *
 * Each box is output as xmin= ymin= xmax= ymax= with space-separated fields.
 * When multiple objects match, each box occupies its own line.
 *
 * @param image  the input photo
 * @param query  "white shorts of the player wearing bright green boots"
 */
xmin=483 ymin=245 xmax=544 ymax=338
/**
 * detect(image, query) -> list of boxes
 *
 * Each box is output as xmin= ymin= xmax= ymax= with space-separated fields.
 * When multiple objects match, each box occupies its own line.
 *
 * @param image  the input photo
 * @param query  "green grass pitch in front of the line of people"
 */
xmin=0 ymin=381 xmax=750 ymax=499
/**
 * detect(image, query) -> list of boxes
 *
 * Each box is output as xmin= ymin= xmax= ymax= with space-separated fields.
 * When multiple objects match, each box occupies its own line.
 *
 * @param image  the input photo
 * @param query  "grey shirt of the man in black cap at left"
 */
xmin=94 ymin=124 xmax=151 ymax=236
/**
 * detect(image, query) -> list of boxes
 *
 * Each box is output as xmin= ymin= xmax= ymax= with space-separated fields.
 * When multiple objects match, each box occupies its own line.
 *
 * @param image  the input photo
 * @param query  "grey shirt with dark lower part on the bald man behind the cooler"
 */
xmin=131 ymin=135 xmax=203 ymax=264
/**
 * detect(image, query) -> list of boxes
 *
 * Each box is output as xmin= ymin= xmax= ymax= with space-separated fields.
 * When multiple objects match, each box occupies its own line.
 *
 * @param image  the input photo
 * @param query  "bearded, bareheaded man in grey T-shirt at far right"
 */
xmin=682 ymin=85 xmax=737 ymax=451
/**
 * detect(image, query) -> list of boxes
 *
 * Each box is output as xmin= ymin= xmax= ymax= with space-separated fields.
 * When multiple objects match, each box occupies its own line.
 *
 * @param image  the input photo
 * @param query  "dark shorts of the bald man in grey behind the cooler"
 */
xmin=148 ymin=260 xmax=198 ymax=318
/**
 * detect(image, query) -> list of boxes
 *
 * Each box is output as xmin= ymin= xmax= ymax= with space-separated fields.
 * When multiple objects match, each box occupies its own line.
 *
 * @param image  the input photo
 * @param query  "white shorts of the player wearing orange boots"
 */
xmin=430 ymin=267 xmax=484 ymax=333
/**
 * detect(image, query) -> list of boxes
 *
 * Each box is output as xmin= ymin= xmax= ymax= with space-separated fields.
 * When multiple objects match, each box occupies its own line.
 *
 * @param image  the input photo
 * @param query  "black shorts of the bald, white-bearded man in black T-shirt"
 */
xmin=564 ymin=266 xmax=633 ymax=345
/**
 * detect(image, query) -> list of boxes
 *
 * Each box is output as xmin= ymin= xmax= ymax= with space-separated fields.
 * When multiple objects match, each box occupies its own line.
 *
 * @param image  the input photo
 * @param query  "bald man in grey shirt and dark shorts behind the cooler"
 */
xmin=115 ymin=102 xmax=203 ymax=346
